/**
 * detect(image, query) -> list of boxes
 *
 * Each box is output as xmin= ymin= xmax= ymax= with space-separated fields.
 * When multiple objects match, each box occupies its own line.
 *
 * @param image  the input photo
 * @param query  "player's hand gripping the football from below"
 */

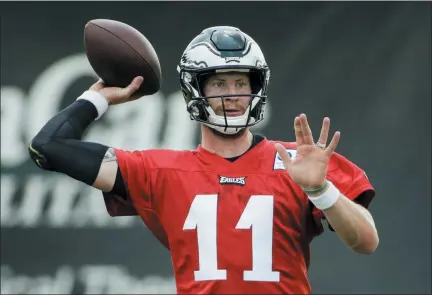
xmin=89 ymin=76 xmax=144 ymax=105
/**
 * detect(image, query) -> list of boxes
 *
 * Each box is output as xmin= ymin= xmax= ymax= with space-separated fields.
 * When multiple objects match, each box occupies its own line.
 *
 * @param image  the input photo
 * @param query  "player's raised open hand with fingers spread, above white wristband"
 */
xmin=275 ymin=114 xmax=340 ymax=190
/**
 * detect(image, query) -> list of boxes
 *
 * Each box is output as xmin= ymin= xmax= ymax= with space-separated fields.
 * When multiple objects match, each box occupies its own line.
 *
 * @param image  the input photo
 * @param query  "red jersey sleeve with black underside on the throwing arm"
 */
xmin=103 ymin=149 xmax=152 ymax=216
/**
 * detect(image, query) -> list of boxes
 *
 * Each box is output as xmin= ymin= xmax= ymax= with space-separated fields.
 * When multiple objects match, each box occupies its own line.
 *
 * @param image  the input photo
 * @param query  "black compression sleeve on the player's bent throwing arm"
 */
xmin=29 ymin=100 xmax=108 ymax=185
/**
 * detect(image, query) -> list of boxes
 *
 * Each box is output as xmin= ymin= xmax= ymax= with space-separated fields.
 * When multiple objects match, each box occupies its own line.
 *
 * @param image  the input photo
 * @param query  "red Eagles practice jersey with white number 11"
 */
xmin=105 ymin=139 xmax=373 ymax=294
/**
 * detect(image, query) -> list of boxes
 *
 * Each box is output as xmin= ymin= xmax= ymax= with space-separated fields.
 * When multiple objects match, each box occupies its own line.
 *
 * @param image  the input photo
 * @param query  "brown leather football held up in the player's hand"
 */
xmin=84 ymin=19 xmax=162 ymax=96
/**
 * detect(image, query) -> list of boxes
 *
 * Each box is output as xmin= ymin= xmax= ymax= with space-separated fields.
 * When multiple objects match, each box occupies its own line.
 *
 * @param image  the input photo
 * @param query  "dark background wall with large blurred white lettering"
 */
xmin=0 ymin=2 xmax=431 ymax=294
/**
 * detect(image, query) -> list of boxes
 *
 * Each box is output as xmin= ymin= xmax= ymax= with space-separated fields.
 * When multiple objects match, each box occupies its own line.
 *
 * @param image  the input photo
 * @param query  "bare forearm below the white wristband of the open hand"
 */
xmin=323 ymin=194 xmax=379 ymax=254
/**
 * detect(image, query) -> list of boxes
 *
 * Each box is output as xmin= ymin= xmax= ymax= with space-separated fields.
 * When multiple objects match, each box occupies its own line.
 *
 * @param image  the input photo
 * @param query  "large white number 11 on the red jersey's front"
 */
xmin=183 ymin=195 xmax=280 ymax=282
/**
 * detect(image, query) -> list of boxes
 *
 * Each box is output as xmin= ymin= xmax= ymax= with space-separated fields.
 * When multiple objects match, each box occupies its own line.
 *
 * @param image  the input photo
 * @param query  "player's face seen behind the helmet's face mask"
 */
xmin=203 ymin=73 xmax=252 ymax=117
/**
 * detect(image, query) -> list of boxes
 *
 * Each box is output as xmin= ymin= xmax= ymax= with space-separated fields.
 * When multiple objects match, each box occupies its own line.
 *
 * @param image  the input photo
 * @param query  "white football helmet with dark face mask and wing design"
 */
xmin=177 ymin=26 xmax=270 ymax=134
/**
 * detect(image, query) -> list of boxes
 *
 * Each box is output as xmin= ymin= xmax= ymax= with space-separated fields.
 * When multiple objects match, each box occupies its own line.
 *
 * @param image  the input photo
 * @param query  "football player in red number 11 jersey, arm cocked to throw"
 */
xmin=29 ymin=26 xmax=378 ymax=294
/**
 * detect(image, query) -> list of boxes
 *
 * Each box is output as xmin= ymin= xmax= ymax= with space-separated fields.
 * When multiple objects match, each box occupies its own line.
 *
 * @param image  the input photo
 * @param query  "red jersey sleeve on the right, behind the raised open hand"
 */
xmin=310 ymin=153 xmax=375 ymax=232
